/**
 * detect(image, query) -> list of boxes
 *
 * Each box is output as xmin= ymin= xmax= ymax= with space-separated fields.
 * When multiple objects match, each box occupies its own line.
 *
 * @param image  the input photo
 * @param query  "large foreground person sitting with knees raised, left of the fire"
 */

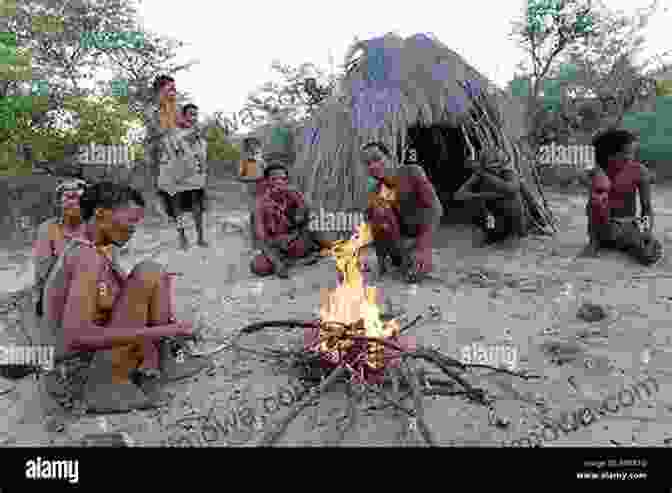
xmin=44 ymin=182 xmax=207 ymax=412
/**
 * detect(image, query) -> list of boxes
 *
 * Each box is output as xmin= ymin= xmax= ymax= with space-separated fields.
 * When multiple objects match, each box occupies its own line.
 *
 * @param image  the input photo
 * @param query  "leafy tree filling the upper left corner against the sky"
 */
xmin=0 ymin=0 xmax=195 ymax=173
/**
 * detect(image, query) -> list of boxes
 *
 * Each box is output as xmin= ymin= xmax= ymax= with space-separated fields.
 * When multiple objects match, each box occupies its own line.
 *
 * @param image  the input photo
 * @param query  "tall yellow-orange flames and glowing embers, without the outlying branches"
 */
xmin=319 ymin=223 xmax=400 ymax=375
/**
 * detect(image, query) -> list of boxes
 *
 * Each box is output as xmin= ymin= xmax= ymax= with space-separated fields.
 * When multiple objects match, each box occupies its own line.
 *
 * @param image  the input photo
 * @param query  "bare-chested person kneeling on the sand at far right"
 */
xmin=584 ymin=130 xmax=663 ymax=265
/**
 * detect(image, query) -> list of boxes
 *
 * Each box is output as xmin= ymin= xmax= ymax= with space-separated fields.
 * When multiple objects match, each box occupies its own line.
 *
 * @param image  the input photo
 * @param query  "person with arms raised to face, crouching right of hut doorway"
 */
xmin=455 ymin=147 xmax=527 ymax=245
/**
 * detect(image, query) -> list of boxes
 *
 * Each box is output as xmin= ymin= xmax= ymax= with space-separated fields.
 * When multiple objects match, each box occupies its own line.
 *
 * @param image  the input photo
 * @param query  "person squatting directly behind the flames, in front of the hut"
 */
xmin=362 ymin=142 xmax=443 ymax=283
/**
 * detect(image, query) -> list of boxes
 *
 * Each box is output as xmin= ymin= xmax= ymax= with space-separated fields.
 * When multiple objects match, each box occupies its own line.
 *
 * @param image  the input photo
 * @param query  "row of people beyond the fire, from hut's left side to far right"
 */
xmin=240 ymin=129 xmax=663 ymax=283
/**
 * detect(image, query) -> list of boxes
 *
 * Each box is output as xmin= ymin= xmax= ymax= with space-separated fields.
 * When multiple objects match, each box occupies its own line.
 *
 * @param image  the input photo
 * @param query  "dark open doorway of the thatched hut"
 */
xmin=400 ymin=125 xmax=478 ymax=224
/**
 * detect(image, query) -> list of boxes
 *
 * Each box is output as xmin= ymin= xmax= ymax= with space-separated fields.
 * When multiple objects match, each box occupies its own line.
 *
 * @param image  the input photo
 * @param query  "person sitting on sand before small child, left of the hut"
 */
xmin=250 ymin=163 xmax=316 ymax=279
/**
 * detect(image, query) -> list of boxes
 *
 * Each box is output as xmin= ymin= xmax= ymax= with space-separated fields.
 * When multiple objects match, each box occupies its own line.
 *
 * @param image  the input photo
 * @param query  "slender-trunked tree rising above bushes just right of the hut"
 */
xmin=511 ymin=0 xmax=598 ymax=146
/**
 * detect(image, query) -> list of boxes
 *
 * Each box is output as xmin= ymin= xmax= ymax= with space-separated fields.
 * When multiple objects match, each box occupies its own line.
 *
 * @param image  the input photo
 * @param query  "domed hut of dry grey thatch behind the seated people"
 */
xmin=293 ymin=34 xmax=554 ymax=236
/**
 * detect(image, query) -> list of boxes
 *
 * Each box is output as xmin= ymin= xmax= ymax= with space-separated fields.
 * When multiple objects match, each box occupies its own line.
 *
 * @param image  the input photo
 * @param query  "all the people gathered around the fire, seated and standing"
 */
xmin=26 ymin=71 xmax=663 ymax=412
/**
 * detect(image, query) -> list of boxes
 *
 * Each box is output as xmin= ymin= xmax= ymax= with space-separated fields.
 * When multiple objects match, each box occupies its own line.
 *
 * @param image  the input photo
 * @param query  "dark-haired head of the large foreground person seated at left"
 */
xmin=81 ymin=182 xmax=145 ymax=246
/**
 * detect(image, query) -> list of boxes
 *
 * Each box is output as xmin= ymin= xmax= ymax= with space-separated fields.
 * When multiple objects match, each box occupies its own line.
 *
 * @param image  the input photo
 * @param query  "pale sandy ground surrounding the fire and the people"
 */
xmin=0 ymin=178 xmax=672 ymax=446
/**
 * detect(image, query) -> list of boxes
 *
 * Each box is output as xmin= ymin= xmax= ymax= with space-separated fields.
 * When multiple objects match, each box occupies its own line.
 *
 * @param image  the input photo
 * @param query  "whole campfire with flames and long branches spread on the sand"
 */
xmin=231 ymin=223 xmax=539 ymax=446
